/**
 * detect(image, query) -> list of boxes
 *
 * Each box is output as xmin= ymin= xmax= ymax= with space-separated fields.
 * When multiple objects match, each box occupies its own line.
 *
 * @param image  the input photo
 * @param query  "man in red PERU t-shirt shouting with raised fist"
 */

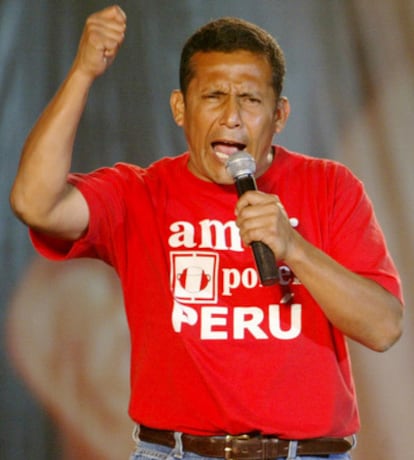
xmin=11 ymin=6 xmax=402 ymax=459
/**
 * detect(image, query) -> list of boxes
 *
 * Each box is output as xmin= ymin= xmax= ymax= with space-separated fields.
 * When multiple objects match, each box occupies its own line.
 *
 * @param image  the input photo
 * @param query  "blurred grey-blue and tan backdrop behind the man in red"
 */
xmin=0 ymin=0 xmax=414 ymax=460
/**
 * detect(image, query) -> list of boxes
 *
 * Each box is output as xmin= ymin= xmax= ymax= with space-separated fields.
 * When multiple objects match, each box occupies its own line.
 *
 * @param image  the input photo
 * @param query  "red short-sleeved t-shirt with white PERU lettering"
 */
xmin=32 ymin=147 xmax=402 ymax=439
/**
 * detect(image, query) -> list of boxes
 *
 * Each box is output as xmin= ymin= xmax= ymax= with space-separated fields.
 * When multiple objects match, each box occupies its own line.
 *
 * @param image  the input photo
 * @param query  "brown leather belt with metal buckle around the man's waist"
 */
xmin=139 ymin=425 xmax=352 ymax=460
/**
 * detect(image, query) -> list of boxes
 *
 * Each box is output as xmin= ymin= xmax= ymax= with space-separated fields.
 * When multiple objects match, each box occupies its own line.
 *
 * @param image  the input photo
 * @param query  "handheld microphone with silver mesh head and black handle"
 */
xmin=226 ymin=151 xmax=279 ymax=286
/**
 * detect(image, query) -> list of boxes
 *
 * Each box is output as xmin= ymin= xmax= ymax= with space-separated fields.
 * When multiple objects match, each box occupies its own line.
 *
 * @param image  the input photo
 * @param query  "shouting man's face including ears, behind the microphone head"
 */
xmin=171 ymin=51 xmax=289 ymax=184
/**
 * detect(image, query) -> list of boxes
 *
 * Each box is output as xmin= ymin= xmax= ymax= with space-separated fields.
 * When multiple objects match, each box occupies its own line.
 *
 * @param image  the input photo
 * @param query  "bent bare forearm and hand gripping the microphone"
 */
xmin=236 ymin=191 xmax=403 ymax=351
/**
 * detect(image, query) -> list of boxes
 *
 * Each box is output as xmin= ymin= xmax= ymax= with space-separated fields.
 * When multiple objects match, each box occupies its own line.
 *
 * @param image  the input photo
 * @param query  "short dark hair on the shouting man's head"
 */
xmin=180 ymin=17 xmax=286 ymax=98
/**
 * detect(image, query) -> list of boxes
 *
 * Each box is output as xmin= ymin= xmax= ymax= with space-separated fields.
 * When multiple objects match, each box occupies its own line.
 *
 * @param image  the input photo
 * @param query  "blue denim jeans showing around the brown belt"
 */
xmin=130 ymin=441 xmax=351 ymax=460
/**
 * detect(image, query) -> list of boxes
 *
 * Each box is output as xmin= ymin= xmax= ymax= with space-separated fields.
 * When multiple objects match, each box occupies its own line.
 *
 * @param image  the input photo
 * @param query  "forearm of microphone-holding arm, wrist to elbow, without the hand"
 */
xmin=286 ymin=233 xmax=402 ymax=351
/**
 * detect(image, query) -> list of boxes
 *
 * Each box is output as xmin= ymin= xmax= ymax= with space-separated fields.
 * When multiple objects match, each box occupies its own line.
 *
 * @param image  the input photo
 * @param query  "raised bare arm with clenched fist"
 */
xmin=10 ymin=6 xmax=126 ymax=239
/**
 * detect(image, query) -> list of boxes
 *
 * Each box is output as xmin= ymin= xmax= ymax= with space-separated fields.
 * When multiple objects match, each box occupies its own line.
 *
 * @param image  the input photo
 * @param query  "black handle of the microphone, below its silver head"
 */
xmin=235 ymin=174 xmax=279 ymax=286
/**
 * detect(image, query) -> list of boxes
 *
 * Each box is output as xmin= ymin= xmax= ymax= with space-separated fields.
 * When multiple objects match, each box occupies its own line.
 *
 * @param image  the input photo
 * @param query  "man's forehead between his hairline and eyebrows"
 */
xmin=190 ymin=50 xmax=272 ymax=86
